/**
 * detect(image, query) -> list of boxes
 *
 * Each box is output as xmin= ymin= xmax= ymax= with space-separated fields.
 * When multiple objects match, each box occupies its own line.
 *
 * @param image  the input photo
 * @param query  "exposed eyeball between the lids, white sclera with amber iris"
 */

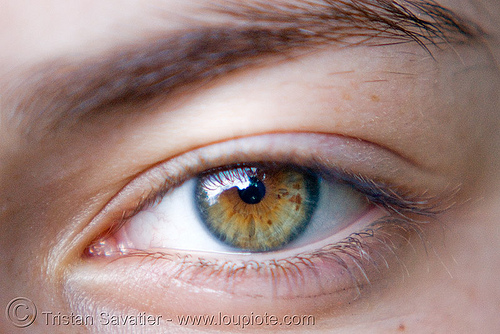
xmin=90 ymin=164 xmax=369 ymax=254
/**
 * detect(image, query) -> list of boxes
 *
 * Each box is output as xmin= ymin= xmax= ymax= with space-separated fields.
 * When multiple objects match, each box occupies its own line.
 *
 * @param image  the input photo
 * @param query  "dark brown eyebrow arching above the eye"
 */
xmin=7 ymin=0 xmax=483 ymax=131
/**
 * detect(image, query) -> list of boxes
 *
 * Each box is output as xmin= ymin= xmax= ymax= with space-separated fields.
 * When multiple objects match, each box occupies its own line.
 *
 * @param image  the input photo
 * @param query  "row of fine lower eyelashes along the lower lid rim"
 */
xmin=102 ymin=215 xmax=426 ymax=300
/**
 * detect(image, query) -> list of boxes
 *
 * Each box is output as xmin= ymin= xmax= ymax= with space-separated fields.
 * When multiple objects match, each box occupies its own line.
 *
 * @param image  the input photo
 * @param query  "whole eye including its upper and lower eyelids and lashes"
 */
xmin=75 ymin=134 xmax=442 ymax=313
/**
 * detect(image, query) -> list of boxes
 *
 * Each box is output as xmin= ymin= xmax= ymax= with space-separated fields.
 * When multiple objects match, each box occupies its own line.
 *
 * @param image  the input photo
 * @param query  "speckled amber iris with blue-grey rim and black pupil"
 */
xmin=196 ymin=166 xmax=319 ymax=252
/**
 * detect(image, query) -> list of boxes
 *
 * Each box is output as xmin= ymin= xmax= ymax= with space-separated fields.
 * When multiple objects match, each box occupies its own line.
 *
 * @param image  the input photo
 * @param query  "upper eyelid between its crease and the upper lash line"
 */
xmin=114 ymin=133 xmax=459 ymax=219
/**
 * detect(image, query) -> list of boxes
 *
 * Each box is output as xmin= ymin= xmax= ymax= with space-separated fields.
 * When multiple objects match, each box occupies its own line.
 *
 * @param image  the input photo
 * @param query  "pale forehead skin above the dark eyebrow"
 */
xmin=0 ymin=0 xmax=500 ymax=60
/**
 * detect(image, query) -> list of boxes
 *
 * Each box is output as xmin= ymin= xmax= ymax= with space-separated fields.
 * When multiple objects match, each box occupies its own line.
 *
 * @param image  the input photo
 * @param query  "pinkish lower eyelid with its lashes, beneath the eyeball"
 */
xmin=67 ymin=214 xmax=418 ymax=320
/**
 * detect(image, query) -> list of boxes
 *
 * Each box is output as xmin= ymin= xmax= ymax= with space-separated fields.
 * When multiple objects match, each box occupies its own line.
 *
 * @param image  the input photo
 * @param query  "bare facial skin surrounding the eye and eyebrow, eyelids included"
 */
xmin=0 ymin=0 xmax=500 ymax=333
